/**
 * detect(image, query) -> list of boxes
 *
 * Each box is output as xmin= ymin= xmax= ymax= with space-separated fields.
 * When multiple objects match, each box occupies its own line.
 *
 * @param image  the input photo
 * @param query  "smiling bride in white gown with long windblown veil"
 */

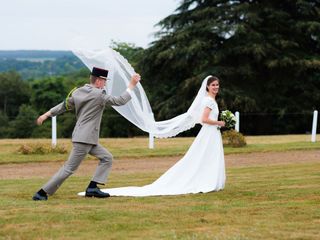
xmin=73 ymin=48 xmax=226 ymax=197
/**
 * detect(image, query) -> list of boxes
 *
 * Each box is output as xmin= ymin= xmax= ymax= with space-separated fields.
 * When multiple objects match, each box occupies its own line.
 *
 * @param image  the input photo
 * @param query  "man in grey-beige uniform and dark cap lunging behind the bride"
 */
xmin=32 ymin=67 xmax=140 ymax=201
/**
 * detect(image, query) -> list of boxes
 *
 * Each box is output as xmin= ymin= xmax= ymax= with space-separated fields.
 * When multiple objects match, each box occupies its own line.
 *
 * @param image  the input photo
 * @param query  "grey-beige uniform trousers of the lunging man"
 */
xmin=42 ymin=142 xmax=113 ymax=195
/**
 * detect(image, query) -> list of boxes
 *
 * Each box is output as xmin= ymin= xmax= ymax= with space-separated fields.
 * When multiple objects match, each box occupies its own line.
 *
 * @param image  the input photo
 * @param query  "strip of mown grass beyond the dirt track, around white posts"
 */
xmin=0 ymin=134 xmax=320 ymax=165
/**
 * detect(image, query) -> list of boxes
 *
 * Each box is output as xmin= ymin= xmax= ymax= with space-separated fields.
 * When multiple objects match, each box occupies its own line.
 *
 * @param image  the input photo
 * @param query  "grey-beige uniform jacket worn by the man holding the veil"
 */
xmin=50 ymin=84 xmax=131 ymax=145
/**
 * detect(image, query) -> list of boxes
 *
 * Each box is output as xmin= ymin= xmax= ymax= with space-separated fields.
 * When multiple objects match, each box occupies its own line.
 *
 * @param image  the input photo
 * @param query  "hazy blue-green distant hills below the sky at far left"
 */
xmin=0 ymin=50 xmax=85 ymax=79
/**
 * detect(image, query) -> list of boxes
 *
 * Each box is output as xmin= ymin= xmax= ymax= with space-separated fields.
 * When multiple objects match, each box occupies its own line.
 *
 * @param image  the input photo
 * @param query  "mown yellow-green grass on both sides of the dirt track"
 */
xmin=0 ymin=135 xmax=320 ymax=239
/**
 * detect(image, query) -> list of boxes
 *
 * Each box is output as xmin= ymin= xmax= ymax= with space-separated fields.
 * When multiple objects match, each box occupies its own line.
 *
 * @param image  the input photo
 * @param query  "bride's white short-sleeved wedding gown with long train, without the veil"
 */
xmin=80 ymin=97 xmax=226 ymax=197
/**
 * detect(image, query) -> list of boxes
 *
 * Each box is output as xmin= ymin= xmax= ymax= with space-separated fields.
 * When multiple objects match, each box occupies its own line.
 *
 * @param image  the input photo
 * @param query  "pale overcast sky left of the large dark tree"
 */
xmin=0 ymin=0 xmax=181 ymax=50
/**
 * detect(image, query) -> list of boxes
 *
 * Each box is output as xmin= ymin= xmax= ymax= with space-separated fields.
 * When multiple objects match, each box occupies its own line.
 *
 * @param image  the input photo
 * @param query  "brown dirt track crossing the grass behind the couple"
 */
xmin=0 ymin=150 xmax=320 ymax=179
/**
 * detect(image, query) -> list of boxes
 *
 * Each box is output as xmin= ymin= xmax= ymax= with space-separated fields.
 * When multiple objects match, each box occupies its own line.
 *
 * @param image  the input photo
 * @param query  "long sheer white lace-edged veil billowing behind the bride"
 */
xmin=73 ymin=48 xmax=210 ymax=138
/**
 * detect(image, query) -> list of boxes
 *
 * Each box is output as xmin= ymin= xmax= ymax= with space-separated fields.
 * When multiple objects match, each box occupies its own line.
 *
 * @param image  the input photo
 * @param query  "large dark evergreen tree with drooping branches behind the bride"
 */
xmin=140 ymin=0 xmax=320 ymax=124
